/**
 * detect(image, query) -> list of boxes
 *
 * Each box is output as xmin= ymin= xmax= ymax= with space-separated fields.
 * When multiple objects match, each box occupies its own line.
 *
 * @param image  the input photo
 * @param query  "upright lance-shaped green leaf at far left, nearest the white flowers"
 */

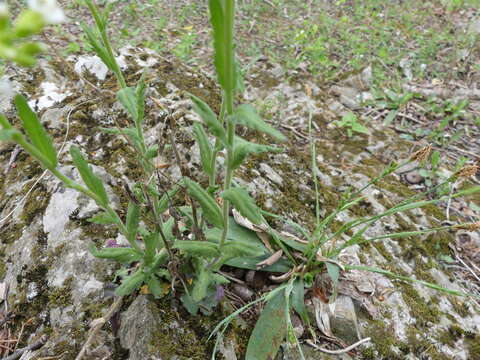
xmin=15 ymin=95 xmax=58 ymax=169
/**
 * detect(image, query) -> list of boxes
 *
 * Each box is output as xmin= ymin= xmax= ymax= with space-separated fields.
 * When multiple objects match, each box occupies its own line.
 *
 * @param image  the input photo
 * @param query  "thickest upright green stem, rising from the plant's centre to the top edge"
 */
xmin=219 ymin=0 xmax=236 ymax=251
